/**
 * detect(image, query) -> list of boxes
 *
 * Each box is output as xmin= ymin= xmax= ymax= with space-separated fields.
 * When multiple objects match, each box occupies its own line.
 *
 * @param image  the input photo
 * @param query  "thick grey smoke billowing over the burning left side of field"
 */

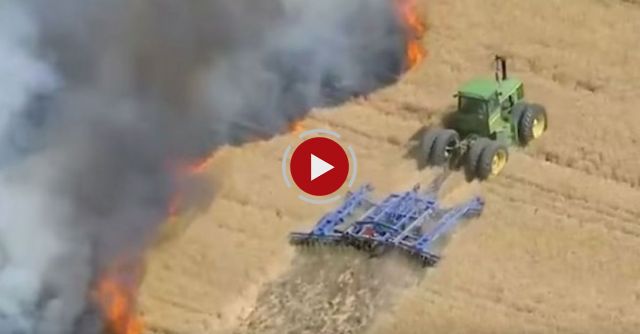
xmin=0 ymin=0 xmax=404 ymax=334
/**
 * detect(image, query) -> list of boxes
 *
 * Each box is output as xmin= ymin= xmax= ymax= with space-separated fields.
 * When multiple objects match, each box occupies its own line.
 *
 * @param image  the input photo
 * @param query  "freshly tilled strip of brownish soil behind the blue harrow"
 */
xmin=237 ymin=246 xmax=424 ymax=334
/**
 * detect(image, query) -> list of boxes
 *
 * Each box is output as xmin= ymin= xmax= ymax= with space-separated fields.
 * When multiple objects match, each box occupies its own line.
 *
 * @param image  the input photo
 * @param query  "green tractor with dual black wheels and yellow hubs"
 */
xmin=421 ymin=56 xmax=547 ymax=180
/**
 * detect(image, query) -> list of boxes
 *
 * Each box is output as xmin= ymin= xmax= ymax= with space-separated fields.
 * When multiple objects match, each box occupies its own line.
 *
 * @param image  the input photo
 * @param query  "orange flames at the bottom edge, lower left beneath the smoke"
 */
xmin=93 ymin=260 xmax=144 ymax=334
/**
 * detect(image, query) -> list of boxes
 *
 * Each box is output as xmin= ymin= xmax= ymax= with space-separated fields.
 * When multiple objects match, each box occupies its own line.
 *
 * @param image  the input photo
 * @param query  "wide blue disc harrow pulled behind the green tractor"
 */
xmin=289 ymin=175 xmax=484 ymax=266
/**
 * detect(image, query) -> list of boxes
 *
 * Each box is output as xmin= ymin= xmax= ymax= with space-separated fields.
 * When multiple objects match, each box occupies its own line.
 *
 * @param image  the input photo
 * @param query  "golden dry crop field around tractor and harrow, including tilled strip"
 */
xmin=140 ymin=0 xmax=640 ymax=334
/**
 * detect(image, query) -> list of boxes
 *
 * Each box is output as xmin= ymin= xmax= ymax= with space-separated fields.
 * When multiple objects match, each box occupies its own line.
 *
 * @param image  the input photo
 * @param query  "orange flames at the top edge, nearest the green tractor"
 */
xmin=394 ymin=0 xmax=427 ymax=70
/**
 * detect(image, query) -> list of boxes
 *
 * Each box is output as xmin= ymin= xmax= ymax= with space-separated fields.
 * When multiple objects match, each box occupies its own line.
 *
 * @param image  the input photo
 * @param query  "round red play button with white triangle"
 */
xmin=289 ymin=137 xmax=349 ymax=196
